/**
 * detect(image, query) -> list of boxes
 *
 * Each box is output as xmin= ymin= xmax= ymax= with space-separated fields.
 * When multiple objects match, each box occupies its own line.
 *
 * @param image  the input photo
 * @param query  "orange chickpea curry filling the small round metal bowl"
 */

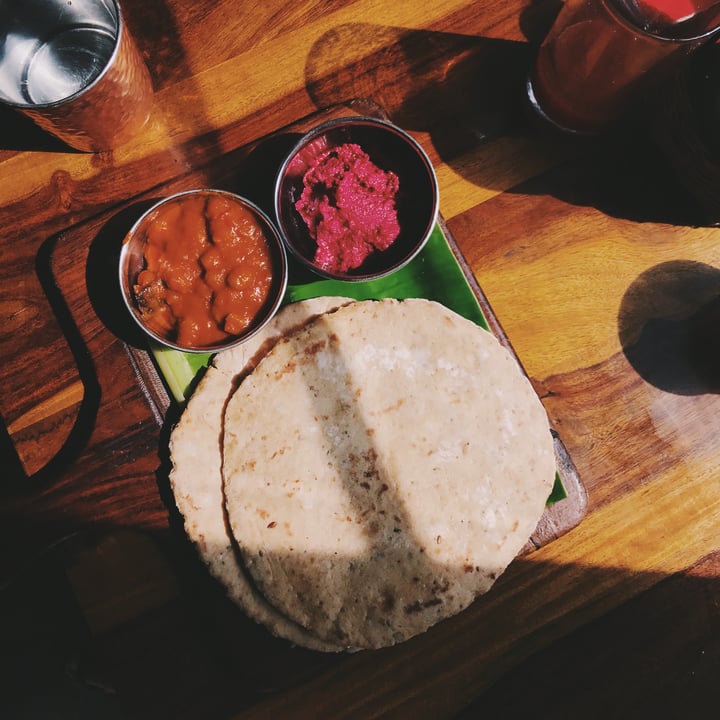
xmin=133 ymin=193 xmax=273 ymax=349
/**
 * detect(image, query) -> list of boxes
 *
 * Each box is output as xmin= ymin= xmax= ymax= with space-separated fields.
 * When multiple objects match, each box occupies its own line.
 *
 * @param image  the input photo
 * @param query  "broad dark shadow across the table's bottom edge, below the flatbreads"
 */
xmin=0 ymin=531 xmax=720 ymax=720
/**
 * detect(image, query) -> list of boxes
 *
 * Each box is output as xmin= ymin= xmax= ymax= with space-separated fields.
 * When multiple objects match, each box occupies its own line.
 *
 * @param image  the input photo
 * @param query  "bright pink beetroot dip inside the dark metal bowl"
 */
xmin=295 ymin=143 xmax=400 ymax=272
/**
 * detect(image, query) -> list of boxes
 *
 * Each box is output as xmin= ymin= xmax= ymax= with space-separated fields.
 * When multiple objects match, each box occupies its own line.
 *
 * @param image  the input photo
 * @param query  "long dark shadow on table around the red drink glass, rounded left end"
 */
xmin=305 ymin=8 xmax=708 ymax=231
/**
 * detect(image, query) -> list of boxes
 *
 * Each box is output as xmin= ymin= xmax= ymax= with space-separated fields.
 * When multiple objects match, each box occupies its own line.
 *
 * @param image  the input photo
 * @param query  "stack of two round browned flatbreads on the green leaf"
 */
xmin=170 ymin=298 xmax=556 ymax=651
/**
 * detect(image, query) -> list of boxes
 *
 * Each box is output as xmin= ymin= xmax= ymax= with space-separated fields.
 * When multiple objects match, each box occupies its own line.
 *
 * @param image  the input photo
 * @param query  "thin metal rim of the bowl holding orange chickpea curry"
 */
xmin=118 ymin=188 xmax=288 ymax=354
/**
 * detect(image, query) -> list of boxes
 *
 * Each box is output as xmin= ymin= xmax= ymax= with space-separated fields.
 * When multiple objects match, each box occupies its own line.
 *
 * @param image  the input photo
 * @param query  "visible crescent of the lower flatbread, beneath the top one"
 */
xmin=170 ymin=297 xmax=349 ymax=651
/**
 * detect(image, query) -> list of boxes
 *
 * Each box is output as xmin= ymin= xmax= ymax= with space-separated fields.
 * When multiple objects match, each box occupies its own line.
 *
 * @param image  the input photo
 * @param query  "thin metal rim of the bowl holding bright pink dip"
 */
xmin=273 ymin=115 xmax=440 ymax=282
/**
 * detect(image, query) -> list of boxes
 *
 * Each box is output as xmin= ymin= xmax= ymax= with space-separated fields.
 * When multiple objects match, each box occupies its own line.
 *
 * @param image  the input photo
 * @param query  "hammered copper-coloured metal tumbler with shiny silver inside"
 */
xmin=0 ymin=0 xmax=153 ymax=152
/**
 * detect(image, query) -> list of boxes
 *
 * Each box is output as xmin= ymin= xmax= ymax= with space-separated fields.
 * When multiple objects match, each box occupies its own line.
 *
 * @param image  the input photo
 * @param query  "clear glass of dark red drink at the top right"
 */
xmin=527 ymin=0 xmax=720 ymax=133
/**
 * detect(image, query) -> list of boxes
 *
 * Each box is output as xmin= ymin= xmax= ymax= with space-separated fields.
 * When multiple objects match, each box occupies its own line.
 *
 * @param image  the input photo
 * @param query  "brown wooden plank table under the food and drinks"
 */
xmin=0 ymin=0 xmax=720 ymax=718
